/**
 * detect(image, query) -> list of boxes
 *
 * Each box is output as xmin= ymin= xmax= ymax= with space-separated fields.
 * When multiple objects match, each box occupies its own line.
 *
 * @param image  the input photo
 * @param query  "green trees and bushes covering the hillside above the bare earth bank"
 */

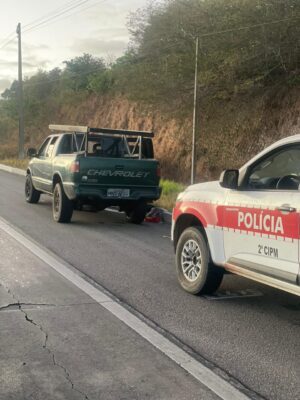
xmin=0 ymin=0 xmax=300 ymax=175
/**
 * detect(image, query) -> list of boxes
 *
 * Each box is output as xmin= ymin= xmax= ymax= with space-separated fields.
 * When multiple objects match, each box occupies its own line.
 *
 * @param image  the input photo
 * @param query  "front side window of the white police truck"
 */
xmin=247 ymin=147 xmax=300 ymax=190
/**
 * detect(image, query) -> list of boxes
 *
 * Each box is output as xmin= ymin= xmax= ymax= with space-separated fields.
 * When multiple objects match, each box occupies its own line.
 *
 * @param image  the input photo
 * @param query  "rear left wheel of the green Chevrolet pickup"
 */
xmin=52 ymin=182 xmax=73 ymax=223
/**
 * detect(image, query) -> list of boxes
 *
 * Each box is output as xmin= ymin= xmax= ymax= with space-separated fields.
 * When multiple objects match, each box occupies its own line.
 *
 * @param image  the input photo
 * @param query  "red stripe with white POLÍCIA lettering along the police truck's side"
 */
xmin=173 ymin=201 xmax=299 ymax=239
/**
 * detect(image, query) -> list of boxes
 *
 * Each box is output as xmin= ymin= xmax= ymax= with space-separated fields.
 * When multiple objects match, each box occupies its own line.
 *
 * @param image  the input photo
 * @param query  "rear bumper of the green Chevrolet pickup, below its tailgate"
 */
xmin=64 ymin=183 xmax=161 ymax=203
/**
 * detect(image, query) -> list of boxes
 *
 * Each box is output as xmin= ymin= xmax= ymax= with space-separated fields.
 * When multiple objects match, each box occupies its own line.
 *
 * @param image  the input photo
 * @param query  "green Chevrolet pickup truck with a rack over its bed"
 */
xmin=25 ymin=125 xmax=161 ymax=224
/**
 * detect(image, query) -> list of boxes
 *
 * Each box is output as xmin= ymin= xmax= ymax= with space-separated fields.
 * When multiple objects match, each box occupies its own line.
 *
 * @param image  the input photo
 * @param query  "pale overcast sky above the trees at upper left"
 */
xmin=0 ymin=0 xmax=147 ymax=93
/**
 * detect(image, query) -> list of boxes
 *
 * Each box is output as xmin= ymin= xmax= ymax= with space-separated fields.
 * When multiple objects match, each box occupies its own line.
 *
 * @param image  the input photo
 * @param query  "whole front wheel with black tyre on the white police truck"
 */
xmin=176 ymin=227 xmax=224 ymax=294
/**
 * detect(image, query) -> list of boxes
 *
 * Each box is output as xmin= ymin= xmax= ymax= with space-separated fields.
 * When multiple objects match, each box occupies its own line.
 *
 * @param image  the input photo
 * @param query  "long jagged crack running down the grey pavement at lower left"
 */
xmin=0 ymin=283 xmax=90 ymax=400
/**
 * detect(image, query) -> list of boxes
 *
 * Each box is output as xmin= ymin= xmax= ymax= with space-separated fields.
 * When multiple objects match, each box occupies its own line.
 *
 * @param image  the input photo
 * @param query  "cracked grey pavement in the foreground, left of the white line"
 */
xmin=0 ymin=229 xmax=216 ymax=400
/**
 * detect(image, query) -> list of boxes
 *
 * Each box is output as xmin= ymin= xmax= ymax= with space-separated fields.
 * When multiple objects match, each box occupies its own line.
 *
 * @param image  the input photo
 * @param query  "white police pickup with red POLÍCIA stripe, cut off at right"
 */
xmin=172 ymin=135 xmax=300 ymax=296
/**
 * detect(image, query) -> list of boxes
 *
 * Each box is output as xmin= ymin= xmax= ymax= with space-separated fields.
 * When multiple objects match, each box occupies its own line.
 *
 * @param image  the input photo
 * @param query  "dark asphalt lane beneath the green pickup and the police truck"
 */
xmin=0 ymin=172 xmax=300 ymax=400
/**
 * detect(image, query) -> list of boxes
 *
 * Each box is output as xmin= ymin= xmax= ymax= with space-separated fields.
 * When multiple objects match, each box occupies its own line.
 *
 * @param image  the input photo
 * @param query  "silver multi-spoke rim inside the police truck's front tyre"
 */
xmin=181 ymin=239 xmax=202 ymax=282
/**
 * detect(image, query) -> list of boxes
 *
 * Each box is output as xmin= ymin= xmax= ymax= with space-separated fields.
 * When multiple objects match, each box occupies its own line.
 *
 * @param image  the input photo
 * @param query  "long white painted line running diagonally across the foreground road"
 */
xmin=0 ymin=217 xmax=249 ymax=400
